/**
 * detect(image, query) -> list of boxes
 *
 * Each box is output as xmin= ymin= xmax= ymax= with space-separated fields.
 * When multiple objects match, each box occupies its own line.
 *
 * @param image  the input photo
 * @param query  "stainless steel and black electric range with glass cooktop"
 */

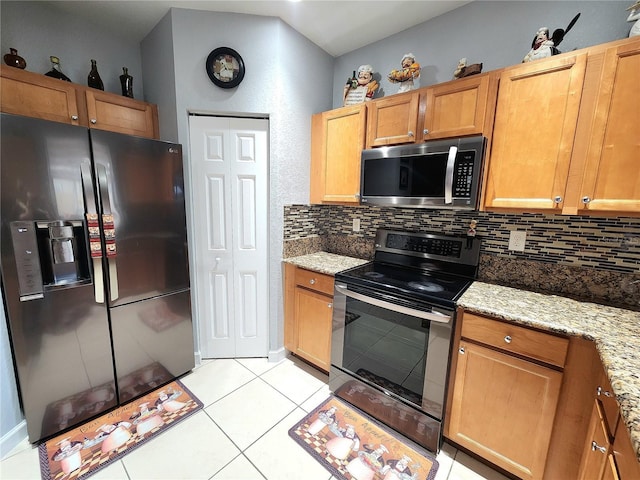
xmin=329 ymin=230 xmax=480 ymax=453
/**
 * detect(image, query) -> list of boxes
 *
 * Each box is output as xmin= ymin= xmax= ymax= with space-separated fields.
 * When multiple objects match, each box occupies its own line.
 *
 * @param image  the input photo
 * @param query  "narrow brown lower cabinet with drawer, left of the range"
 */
xmin=284 ymin=263 xmax=333 ymax=372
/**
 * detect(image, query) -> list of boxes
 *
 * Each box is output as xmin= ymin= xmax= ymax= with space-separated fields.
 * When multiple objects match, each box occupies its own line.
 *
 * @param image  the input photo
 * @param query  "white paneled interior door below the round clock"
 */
xmin=189 ymin=116 xmax=269 ymax=358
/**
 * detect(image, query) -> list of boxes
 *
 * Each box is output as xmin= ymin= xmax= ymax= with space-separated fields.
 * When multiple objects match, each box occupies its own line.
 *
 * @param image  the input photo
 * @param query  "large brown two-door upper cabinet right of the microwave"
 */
xmin=483 ymin=37 xmax=640 ymax=215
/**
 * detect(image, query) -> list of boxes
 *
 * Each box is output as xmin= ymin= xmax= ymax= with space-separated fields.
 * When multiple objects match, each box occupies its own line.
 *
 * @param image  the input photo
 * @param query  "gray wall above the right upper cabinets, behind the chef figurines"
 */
xmin=333 ymin=0 xmax=633 ymax=107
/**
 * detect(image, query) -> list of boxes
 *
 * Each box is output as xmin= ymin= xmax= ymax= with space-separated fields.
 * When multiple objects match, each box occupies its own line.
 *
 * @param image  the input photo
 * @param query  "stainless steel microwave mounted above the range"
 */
xmin=360 ymin=135 xmax=486 ymax=210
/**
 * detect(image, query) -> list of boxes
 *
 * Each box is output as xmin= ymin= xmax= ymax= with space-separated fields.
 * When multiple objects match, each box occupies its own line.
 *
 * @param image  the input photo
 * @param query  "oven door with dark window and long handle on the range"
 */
xmin=331 ymin=283 xmax=454 ymax=420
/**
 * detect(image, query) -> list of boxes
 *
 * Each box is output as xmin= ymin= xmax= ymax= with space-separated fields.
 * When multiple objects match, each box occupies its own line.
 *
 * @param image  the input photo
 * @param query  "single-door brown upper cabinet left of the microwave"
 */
xmin=310 ymin=104 xmax=366 ymax=204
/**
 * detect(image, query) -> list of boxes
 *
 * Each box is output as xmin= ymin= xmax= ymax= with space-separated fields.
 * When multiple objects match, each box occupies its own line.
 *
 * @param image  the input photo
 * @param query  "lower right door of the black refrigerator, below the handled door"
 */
xmin=111 ymin=290 xmax=195 ymax=403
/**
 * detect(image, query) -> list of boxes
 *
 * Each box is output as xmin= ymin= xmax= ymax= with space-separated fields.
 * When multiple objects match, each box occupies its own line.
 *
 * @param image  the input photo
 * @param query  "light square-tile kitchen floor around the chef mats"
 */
xmin=0 ymin=357 xmax=507 ymax=480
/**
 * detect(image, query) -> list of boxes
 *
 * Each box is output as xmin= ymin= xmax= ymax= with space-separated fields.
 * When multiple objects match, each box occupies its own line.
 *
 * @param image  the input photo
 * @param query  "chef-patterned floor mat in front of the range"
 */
xmin=289 ymin=396 xmax=438 ymax=480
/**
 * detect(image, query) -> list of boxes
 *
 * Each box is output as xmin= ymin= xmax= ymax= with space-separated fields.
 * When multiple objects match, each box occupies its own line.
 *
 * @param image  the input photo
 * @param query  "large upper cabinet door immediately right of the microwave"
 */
xmin=484 ymin=53 xmax=587 ymax=213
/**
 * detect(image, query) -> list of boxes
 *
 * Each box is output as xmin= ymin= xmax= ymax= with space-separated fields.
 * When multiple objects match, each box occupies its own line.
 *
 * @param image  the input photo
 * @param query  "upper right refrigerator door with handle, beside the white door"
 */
xmin=91 ymin=130 xmax=189 ymax=306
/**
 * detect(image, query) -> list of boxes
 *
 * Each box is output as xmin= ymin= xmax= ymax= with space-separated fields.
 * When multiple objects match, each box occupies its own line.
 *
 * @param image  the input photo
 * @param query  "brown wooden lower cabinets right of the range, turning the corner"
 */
xmin=445 ymin=309 xmax=640 ymax=480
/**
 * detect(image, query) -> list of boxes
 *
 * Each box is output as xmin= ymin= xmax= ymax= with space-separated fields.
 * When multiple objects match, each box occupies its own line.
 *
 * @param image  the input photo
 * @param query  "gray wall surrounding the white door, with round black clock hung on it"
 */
xmin=142 ymin=9 xmax=333 ymax=364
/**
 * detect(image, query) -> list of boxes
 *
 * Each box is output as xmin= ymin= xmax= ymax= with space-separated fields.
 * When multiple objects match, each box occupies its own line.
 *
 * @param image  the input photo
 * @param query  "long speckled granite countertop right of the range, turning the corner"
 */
xmin=458 ymin=282 xmax=640 ymax=461
